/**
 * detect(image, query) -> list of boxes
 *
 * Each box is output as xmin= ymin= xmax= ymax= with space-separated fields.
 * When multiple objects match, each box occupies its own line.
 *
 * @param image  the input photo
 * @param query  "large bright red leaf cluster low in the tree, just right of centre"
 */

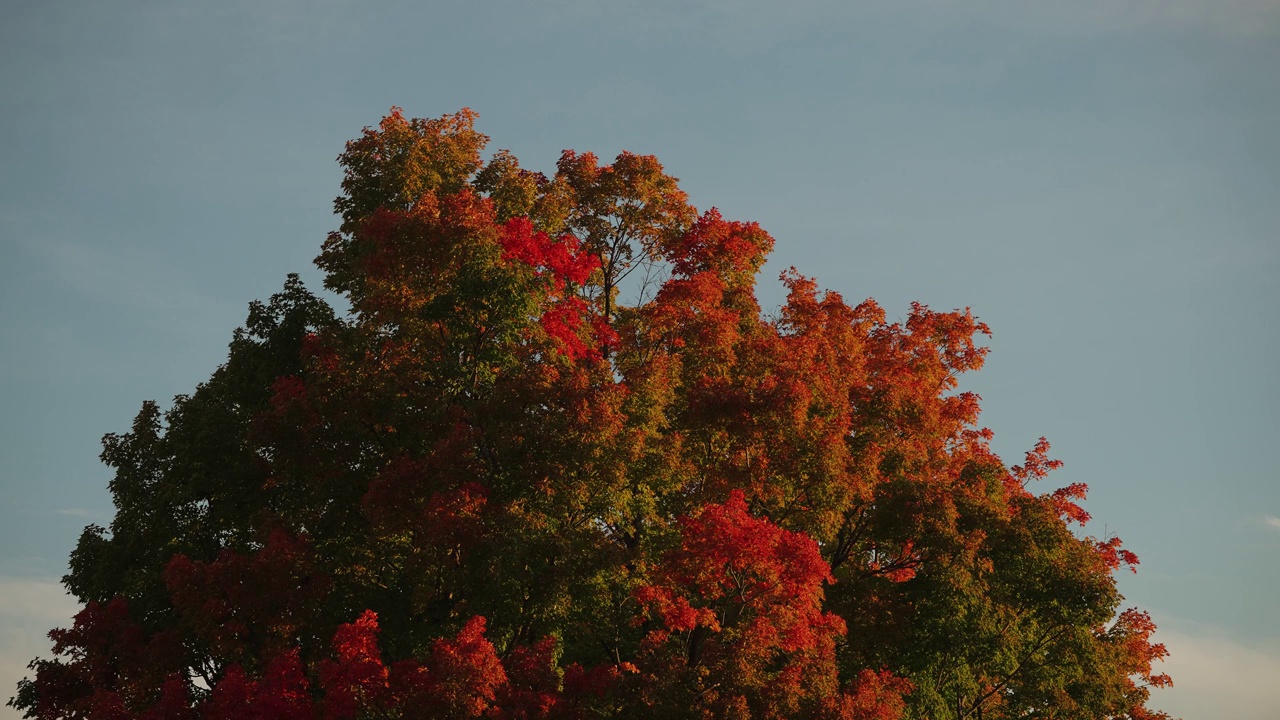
xmin=636 ymin=491 xmax=865 ymax=717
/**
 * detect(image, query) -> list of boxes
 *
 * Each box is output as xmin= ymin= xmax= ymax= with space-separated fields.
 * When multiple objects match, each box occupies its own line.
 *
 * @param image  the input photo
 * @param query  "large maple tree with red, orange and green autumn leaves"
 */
xmin=10 ymin=110 xmax=1170 ymax=720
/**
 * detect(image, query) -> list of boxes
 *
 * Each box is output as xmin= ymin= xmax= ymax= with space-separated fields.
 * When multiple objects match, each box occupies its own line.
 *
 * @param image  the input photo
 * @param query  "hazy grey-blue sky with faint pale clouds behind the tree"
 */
xmin=0 ymin=0 xmax=1280 ymax=720
